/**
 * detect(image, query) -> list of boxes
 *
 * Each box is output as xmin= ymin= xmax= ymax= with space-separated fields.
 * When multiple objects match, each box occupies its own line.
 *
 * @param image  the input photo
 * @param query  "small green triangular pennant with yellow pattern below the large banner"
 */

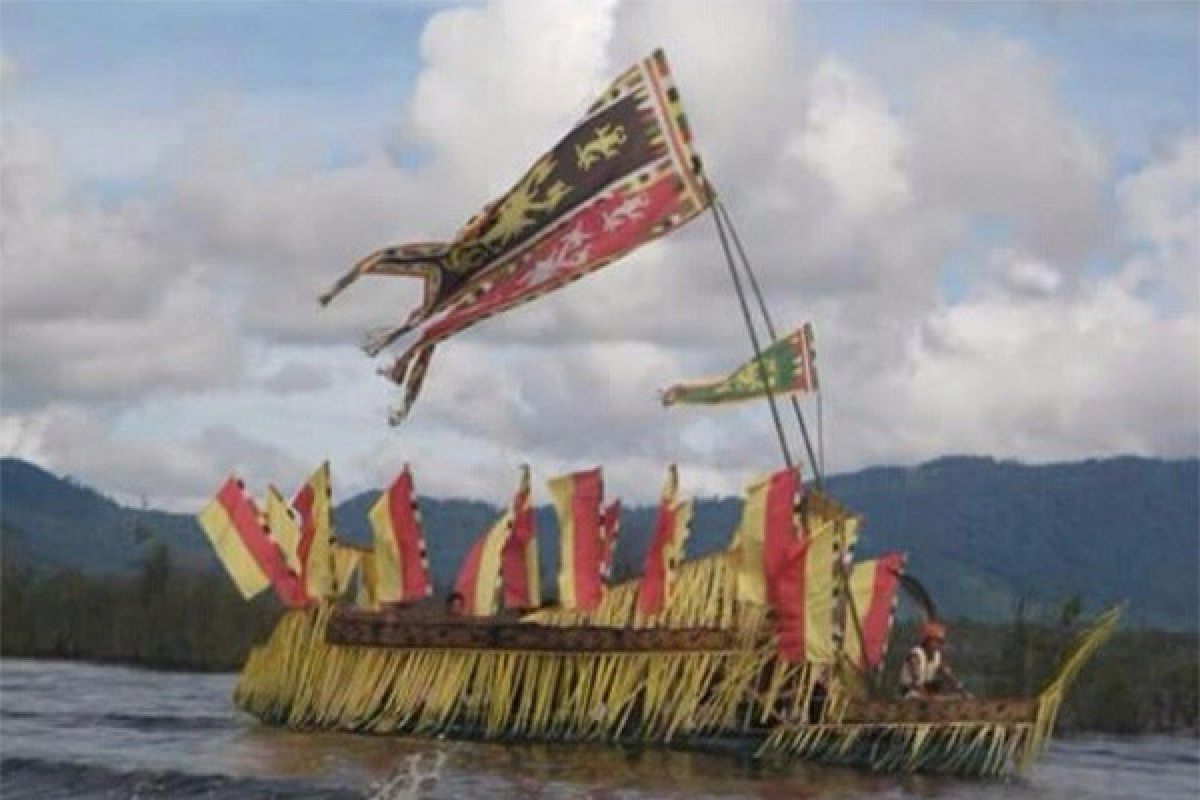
xmin=662 ymin=324 xmax=817 ymax=405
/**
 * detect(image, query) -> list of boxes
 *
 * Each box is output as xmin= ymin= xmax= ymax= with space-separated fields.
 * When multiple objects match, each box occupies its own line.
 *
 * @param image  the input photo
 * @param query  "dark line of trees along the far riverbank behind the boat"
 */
xmin=0 ymin=540 xmax=1200 ymax=733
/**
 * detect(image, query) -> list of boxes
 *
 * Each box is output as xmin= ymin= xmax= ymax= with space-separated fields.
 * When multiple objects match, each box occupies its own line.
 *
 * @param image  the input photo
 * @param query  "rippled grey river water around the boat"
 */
xmin=0 ymin=660 xmax=1200 ymax=800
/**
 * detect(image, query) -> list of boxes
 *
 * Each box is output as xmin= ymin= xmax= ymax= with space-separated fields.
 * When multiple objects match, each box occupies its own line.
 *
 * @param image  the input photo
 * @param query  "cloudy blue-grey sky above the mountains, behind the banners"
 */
xmin=0 ymin=0 xmax=1200 ymax=509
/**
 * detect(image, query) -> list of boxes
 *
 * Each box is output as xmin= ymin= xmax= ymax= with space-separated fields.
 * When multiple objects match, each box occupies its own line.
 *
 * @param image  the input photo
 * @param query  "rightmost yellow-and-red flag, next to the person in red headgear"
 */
xmin=842 ymin=553 xmax=905 ymax=669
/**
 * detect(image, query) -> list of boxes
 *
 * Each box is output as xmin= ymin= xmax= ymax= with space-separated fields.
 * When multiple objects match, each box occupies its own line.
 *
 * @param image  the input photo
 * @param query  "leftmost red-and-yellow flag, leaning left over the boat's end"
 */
xmin=197 ymin=475 xmax=305 ymax=607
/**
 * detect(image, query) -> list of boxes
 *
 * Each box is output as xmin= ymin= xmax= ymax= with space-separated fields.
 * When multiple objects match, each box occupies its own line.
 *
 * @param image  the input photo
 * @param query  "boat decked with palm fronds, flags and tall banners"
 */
xmin=199 ymin=52 xmax=1120 ymax=776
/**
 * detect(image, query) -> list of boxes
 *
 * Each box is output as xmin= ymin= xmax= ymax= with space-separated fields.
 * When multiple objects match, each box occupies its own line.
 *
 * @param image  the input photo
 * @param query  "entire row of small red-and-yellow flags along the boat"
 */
xmin=198 ymin=463 xmax=904 ymax=668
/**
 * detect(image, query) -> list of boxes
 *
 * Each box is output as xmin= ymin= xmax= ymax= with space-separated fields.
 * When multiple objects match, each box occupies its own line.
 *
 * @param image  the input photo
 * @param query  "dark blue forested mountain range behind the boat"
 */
xmin=0 ymin=457 xmax=1200 ymax=630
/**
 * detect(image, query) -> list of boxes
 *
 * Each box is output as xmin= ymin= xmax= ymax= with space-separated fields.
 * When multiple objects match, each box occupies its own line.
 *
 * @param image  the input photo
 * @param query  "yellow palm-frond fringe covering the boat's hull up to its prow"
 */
xmin=234 ymin=553 xmax=1120 ymax=776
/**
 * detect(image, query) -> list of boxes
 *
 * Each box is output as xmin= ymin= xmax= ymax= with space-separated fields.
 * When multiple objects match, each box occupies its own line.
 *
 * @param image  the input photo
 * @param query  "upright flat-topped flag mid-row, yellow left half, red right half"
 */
xmin=546 ymin=467 xmax=604 ymax=612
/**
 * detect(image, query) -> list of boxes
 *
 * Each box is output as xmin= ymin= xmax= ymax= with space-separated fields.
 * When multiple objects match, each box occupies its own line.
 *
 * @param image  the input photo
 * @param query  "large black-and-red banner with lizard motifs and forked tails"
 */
xmin=320 ymin=50 xmax=710 ymax=423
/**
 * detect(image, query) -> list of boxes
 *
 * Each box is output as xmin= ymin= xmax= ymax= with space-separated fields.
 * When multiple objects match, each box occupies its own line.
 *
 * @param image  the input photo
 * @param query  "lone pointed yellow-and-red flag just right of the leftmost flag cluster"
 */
xmin=367 ymin=464 xmax=433 ymax=603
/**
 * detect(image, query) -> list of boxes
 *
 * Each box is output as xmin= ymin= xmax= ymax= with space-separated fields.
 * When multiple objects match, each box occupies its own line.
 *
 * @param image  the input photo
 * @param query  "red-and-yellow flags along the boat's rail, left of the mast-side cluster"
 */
xmin=198 ymin=463 xmax=691 ymax=616
